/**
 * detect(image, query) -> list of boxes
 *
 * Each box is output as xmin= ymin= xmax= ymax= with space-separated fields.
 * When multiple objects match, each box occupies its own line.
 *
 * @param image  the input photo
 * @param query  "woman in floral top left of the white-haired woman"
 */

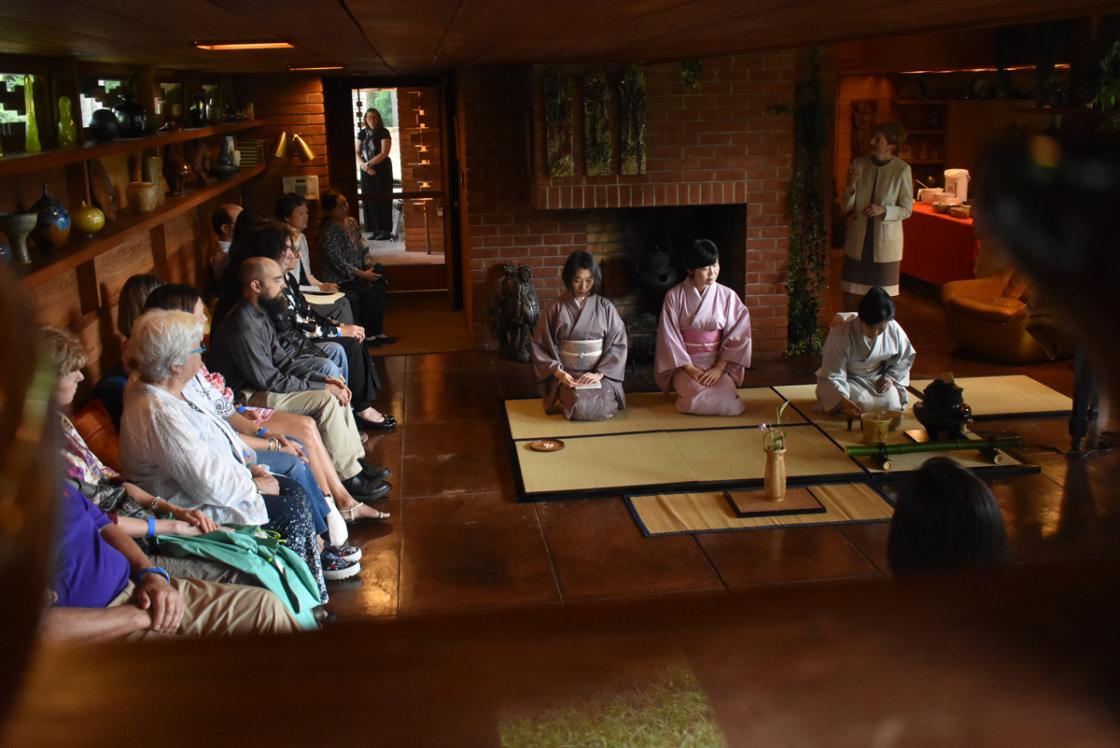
xmin=39 ymin=327 xmax=256 ymax=586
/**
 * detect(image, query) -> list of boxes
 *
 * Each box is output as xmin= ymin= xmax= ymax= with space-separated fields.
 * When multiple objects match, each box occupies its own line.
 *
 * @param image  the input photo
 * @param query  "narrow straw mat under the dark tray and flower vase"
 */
xmin=626 ymin=483 xmax=894 ymax=537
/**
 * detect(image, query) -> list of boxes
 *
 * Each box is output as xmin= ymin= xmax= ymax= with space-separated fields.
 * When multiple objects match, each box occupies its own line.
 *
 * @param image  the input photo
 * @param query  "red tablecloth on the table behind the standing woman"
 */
xmin=902 ymin=203 xmax=980 ymax=286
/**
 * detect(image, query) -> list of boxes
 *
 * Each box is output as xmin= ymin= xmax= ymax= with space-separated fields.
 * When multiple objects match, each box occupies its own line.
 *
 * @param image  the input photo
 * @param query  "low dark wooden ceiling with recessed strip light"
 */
xmin=0 ymin=0 xmax=1120 ymax=75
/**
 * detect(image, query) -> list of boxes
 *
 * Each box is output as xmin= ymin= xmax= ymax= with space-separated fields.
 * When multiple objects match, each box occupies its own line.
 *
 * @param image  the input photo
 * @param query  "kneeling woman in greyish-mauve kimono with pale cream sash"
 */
xmin=533 ymin=252 xmax=626 ymax=421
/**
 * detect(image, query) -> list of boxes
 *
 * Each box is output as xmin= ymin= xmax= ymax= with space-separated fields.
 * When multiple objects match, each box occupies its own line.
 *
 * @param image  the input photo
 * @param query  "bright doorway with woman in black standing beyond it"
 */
xmin=324 ymin=78 xmax=460 ymax=297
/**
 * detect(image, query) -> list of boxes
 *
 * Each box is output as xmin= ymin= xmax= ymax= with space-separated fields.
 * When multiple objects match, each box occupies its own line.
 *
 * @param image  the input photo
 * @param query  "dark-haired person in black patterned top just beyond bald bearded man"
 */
xmin=229 ymin=224 xmax=396 ymax=430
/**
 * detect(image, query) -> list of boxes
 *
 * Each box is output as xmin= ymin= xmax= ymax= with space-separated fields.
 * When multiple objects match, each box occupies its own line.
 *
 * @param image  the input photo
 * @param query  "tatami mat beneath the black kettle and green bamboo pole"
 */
xmin=775 ymin=377 xmax=1033 ymax=474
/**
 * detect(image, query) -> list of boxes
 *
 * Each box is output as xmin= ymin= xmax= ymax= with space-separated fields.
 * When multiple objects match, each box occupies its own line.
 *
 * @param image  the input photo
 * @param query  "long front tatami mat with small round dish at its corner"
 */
xmin=514 ymin=424 xmax=864 ymax=498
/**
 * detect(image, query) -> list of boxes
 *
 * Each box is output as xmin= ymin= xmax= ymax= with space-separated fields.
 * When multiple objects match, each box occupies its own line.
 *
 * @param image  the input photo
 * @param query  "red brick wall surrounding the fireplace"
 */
xmin=458 ymin=52 xmax=795 ymax=358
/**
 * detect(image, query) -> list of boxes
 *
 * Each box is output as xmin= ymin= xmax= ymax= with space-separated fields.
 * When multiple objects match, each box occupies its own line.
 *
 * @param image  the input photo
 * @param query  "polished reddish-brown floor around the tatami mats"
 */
xmin=332 ymin=282 xmax=1120 ymax=617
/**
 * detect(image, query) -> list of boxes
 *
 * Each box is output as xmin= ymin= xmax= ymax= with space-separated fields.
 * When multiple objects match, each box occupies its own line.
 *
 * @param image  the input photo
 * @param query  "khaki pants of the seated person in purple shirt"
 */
xmin=108 ymin=577 xmax=299 ymax=641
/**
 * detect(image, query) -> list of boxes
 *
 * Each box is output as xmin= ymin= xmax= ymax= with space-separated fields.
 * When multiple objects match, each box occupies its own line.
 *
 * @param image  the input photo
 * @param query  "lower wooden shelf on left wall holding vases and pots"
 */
xmin=11 ymin=164 xmax=265 ymax=289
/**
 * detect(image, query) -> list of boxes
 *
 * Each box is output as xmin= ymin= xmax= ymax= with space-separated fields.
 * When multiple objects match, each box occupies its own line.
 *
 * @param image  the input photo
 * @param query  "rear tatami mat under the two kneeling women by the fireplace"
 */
xmin=505 ymin=387 xmax=804 ymax=439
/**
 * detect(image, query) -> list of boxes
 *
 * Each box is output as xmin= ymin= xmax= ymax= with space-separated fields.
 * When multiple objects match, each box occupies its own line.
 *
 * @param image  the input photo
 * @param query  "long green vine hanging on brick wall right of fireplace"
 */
xmin=786 ymin=47 xmax=828 ymax=356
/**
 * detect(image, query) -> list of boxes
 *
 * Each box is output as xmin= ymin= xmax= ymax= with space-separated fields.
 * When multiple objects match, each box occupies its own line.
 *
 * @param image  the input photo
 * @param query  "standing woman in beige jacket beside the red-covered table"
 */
xmin=840 ymin=122 xmax=914 ymax=311
